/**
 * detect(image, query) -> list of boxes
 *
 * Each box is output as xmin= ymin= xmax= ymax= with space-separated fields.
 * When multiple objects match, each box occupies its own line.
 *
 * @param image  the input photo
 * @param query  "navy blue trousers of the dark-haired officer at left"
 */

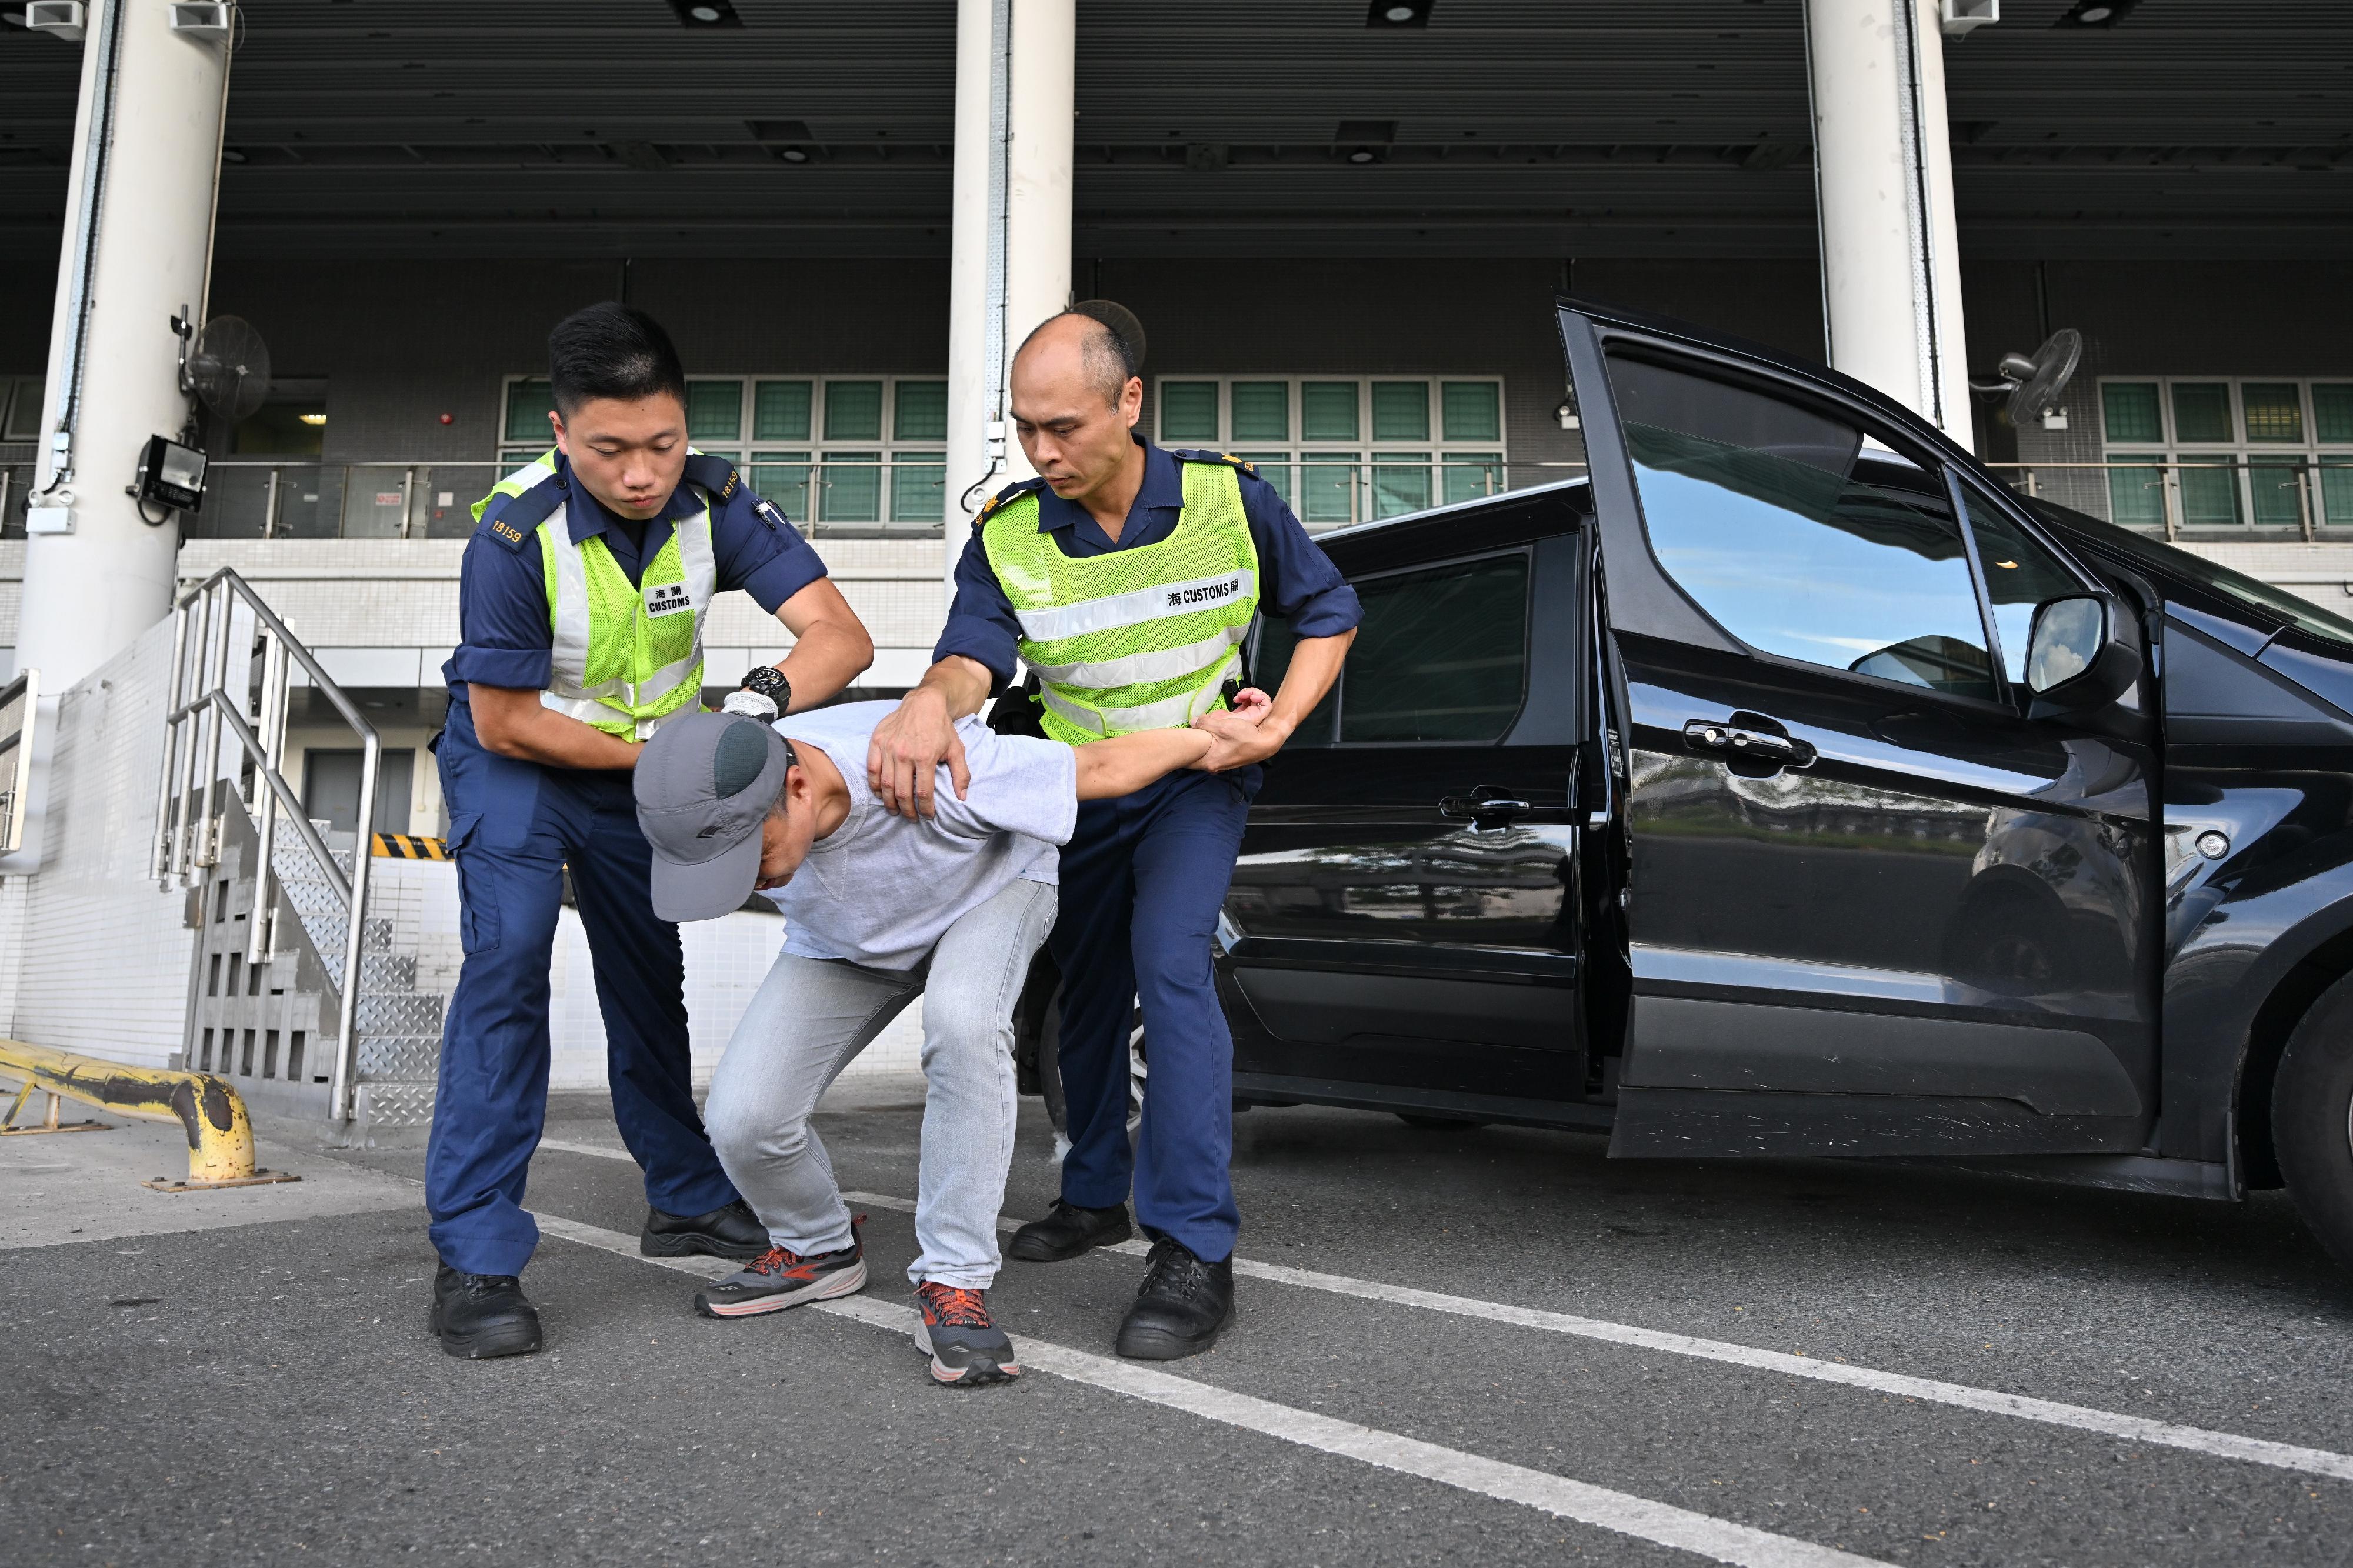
xmin=426 ymin=702 xmax=736 ymax=1274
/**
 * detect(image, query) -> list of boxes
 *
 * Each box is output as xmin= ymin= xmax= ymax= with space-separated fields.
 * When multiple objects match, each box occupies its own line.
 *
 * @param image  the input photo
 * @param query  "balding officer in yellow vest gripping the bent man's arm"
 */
xmin=866 ymin=311 xmax=1360 ymax=1361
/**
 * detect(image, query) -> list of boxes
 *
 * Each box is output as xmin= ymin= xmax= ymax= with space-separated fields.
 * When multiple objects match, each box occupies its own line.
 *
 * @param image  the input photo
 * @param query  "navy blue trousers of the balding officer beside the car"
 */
xmin=1049 ymin=768 xmax=1261 ymax=1262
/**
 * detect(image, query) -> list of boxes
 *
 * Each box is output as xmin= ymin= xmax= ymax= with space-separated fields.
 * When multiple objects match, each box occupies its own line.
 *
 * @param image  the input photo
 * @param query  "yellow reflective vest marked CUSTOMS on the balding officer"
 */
xmin=981 ymin=462 xmax=1259 ymax=744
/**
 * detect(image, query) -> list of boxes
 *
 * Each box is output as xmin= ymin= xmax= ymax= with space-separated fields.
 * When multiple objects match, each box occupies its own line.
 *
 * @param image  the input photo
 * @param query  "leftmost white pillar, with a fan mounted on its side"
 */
xmin=16 ymin=0 xmax=226 ymax=692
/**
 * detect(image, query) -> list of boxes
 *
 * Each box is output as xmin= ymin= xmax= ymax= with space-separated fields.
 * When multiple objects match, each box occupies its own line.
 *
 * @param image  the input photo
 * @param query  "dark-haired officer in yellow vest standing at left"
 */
xmin=426 ymin=303 xmax=873 ymax=1356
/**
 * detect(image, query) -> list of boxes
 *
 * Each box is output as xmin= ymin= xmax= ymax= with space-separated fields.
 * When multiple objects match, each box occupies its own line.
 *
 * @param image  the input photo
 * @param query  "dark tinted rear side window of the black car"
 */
xmin=1339 ymin=551 xmax=1527 ymax=742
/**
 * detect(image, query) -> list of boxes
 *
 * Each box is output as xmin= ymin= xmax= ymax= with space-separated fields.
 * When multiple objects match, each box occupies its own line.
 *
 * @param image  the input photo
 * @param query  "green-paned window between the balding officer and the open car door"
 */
xmin=1153 ymin=376 xmax=1506 ymax=532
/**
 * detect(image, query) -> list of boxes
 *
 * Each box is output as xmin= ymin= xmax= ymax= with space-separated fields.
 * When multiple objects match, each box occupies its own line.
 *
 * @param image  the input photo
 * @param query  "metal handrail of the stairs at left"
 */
xmin=151 ymin=568 xmax=384 ymax=1120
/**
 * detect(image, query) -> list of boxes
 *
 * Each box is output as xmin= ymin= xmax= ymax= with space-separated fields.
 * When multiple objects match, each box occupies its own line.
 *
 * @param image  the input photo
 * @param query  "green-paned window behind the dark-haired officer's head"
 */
xmin=499 ymin=376 xmax=948 ymax=528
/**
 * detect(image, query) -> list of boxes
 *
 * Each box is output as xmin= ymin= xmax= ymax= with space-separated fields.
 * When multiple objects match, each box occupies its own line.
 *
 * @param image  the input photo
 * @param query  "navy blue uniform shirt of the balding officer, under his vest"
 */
xmin=932 ymin=436 xmax=1365 ymax=695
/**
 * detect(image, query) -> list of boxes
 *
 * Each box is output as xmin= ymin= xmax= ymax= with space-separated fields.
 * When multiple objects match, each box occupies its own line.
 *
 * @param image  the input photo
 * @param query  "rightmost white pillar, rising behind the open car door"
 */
xmin=1805 ymin=0 xmax=1974 ymax=448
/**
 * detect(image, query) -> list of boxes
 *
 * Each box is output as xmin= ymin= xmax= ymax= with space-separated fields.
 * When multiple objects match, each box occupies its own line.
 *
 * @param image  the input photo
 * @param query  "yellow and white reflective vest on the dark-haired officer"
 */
xmin=473 ymin=452 xmax=718 ymax=742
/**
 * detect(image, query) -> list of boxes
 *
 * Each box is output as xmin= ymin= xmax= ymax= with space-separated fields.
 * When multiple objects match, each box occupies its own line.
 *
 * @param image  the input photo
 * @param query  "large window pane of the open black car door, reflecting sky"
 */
xmin=1609 ymin=358 xmax=1995 ymax=697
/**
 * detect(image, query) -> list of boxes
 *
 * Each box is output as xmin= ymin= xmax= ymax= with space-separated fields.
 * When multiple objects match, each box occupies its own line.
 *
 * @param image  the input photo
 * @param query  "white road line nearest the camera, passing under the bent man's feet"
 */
xmin=534 ymin=1194 xmax=1889 ymax=1568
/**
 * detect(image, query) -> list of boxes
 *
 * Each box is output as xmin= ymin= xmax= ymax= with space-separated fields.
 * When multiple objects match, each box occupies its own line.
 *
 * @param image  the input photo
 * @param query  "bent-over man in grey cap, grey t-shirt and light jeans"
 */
xmin=635 ymin=702 xmax=1242 ymax=1384
